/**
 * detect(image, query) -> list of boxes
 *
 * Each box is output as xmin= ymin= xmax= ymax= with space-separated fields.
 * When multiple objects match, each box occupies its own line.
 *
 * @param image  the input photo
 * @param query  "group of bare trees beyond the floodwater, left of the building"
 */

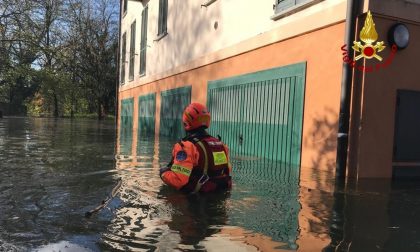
xmin=0 ymin=0 xmax=118 ymax=119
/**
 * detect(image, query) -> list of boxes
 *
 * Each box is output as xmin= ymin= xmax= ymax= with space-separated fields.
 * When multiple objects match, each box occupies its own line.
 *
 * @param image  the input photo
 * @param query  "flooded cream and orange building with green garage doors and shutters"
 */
xmin=118 ymin=0 xmax=420 ymax=181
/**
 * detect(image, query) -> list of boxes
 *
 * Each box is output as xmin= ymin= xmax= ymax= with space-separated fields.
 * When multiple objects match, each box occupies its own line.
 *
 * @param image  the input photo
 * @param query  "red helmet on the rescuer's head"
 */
xmin=182 ymin=102 xmax=210 ymax=131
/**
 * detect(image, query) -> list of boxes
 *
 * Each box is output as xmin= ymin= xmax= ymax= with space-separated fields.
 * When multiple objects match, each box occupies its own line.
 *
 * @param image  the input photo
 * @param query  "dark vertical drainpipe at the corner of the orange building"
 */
xmin=335 ymin=0 xmax=362 ymax=181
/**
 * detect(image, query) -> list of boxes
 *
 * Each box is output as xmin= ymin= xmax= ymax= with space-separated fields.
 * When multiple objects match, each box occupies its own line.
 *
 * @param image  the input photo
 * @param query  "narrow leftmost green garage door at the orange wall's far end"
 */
xmin=120 ymin=98 xmax=134 ymax=155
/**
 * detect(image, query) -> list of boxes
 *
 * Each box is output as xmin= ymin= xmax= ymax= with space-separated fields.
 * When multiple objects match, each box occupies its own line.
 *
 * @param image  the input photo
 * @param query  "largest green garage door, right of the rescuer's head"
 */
xmin=208 ymin=63 xmax=306 ymax=166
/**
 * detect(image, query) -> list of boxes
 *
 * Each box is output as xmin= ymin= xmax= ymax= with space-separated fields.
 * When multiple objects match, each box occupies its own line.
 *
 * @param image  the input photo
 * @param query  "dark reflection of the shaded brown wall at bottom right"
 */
xmin=325 ymin=179 xmax=420 ymax=251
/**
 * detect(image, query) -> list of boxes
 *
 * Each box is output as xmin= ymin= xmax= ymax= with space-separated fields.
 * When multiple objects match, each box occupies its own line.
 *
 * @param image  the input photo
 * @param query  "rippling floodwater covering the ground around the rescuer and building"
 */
xmin=0 ymin=118 xmax=420 ymax=251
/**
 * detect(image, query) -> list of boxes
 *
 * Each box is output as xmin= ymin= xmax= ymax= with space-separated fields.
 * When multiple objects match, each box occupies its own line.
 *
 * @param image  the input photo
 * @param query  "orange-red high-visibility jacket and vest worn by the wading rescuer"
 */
xmin=161 ymin=135 xmax=232 ymax=192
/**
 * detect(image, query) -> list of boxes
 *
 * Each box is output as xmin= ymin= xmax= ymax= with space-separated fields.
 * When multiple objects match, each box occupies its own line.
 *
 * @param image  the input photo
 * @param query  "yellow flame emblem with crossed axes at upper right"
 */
xmin=353 ymin=11 xmax=385 ymax=61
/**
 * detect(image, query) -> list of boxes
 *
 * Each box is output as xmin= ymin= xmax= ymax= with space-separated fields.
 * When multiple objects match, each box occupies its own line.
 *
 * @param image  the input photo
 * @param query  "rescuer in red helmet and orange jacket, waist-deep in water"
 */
xmin=159 ymin=103 xmax=232 ymax=193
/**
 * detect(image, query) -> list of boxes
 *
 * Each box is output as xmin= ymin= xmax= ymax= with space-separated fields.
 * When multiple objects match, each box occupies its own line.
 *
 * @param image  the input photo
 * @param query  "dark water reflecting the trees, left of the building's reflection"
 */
xmin=0 ymin=118 xmax=115 ymax=251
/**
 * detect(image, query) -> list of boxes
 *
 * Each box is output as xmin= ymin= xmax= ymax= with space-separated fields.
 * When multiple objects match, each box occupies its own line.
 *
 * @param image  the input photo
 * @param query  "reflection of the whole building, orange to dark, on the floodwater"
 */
xmin=113 ymin=127 xmax=420 ymax=252
